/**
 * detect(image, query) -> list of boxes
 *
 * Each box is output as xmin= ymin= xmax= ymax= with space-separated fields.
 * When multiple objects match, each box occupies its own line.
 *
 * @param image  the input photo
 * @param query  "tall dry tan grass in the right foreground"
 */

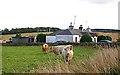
xmin=31 ymin=48 xmax=119 ymax=73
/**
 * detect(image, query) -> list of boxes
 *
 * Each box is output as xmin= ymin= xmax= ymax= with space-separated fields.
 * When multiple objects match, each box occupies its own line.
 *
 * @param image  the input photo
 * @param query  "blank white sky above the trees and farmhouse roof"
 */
xmin=0 ymin=0 xmax=120 ymax=29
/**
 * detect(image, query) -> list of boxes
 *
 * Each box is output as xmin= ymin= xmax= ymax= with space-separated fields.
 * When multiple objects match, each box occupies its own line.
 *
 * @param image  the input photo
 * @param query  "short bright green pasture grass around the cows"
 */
xmin=2 ymin=46 xmax=95 ymax=73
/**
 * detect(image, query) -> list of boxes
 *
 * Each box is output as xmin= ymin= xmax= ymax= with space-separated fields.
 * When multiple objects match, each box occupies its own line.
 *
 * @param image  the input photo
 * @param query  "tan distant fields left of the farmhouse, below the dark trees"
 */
xmin=0 ymin=32 xmax=52 ymax=40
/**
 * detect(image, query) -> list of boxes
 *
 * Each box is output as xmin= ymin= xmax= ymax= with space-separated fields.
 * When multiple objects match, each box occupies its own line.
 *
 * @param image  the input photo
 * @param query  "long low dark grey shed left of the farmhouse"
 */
xmin=12 ymin=36 xmax=35 ymax=43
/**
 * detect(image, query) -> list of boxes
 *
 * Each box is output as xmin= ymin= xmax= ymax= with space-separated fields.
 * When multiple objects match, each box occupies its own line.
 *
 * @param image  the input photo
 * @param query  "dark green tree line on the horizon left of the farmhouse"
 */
xmin=1 ymin=27 xmax=60 ymax=35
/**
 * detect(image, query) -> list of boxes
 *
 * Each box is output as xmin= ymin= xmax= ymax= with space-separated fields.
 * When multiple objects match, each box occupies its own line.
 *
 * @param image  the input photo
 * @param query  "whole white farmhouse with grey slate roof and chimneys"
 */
xmin=46 ymin=23 xmax=97 ymax=43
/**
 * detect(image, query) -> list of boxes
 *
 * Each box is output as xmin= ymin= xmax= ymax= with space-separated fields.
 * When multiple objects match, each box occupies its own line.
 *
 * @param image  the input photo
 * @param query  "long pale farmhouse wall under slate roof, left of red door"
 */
xmin=56 ymin=35 xmax=73 ymax=42
